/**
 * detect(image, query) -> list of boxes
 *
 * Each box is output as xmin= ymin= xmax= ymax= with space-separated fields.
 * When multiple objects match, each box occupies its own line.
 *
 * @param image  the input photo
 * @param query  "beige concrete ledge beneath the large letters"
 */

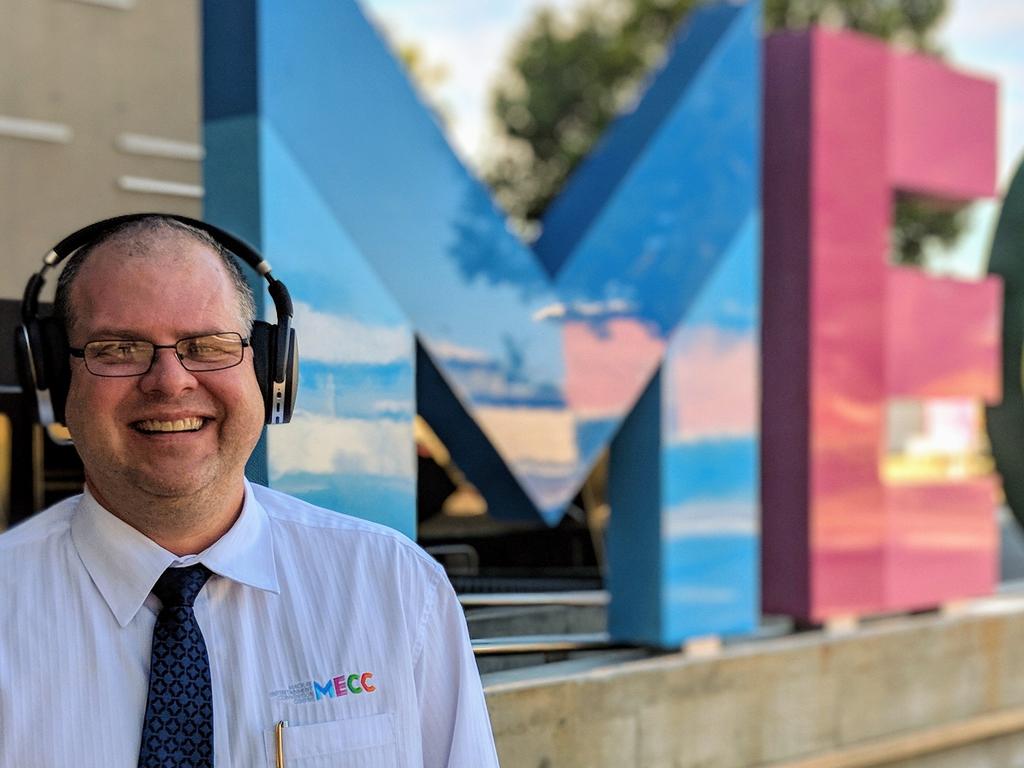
xmin=484 ymin=593 xmax=1024 ymax=768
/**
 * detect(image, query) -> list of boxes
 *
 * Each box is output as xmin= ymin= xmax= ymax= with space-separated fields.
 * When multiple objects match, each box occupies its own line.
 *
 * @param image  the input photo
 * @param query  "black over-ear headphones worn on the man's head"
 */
xmin=14 ymin=213 xmax=299 ymax=434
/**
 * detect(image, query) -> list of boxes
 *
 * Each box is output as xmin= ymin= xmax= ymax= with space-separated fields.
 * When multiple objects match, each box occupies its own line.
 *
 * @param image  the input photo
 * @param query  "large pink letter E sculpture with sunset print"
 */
xmin=762 ymin=30 xmax=999 ymax=621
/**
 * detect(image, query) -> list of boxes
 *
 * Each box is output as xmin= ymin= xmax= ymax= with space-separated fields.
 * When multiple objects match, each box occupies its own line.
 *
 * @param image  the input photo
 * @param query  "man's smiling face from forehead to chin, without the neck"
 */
xmin=60 ymin=234 xmax=263 ymax=501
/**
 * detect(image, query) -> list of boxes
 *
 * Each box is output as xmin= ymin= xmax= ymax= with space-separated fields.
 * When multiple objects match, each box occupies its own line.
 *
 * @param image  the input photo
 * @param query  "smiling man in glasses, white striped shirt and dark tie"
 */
xmin=0 ymin=217 xmax=497 ymax=768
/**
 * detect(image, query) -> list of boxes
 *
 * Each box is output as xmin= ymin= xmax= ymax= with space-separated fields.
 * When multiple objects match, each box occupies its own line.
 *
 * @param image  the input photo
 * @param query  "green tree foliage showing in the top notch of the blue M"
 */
xmin=485 ymin=0 xmax=696 ymax=227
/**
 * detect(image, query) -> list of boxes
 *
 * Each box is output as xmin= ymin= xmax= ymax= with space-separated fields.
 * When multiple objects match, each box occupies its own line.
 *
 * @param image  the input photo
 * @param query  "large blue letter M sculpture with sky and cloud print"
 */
xmin=199 ymin=0 xmax=760 ymax=644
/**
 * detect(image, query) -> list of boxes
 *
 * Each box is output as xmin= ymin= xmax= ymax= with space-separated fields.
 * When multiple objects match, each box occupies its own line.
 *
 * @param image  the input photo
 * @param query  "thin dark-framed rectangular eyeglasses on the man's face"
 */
xmin=68 ymin=333 xmax=249 ymax=376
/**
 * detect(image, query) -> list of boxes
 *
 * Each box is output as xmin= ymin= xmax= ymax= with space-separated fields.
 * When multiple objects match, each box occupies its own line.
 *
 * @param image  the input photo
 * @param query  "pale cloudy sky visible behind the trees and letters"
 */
xmin=361 ymin=0 xmax=1024 ymax=276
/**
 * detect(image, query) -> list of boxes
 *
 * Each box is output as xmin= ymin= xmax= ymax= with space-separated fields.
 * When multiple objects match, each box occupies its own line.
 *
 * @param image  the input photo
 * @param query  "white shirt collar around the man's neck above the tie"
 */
xmin=71 ymin=480 xmax=281 ymax=627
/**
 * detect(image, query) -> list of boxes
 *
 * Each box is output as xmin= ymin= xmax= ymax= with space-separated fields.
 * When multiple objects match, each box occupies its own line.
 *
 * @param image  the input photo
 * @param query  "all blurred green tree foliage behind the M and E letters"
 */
xmin=484 ymin=0 xmax=961 ymax=263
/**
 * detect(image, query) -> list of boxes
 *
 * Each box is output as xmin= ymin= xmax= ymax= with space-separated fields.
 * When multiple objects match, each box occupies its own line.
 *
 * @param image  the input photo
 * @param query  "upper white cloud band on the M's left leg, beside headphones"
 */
xmin=295 ymin=301 xmax=413 ymax=366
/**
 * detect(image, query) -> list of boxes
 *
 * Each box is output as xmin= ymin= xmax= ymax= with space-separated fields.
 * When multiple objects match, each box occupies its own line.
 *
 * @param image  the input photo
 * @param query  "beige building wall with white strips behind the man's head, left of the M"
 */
xmin=0 ymin=0 xmax=202 ymax=300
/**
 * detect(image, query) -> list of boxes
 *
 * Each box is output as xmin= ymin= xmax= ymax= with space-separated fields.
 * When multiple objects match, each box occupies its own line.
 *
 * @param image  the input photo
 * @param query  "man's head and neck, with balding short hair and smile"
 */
xmin=57 ymin=224 xmax=263 ymax=554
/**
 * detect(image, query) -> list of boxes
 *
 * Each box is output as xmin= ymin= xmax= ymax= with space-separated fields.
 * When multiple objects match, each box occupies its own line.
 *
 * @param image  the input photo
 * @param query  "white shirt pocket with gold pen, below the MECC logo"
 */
xmin=263 ymin=713 xmax=398 ymax=768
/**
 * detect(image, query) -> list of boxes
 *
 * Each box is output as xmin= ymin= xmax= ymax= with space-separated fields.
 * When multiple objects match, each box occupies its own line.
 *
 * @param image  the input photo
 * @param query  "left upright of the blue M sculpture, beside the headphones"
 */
xmin=203 ymin=2 xmax=416 ymax=536
